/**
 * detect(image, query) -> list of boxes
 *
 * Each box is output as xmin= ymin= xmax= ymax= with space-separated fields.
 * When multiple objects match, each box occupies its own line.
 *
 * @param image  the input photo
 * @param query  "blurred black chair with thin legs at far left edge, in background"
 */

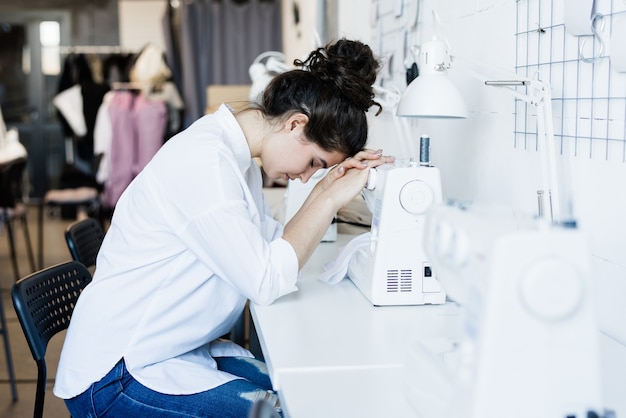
xmin=0 ymin=158 xmax=36 ymax=281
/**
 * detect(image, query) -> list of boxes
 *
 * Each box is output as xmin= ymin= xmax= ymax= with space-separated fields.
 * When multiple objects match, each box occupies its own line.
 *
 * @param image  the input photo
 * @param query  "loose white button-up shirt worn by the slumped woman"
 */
xmin=54 ymin=105 xmax=298 ymax=398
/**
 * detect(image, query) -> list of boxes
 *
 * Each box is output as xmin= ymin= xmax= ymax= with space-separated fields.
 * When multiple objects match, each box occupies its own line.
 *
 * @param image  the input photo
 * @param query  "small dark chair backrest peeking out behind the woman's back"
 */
xmin=65 ymin=218 xmax=104 ymax=267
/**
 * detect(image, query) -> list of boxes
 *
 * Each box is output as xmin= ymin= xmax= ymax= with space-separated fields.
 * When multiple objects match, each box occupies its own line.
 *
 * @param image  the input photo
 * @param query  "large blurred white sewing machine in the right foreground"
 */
xmin=406 ymin=204 xmax=609 ymax=418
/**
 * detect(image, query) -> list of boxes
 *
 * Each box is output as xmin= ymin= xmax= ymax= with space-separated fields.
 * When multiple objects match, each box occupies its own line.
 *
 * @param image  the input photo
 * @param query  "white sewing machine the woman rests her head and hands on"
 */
xmin=348 ymin=145 xmax=446 ymax=305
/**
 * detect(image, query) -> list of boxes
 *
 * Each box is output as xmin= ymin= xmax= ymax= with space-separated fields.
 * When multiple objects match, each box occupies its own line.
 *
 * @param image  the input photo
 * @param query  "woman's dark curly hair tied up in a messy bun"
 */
xmin=254 ymin=39 xmax=382 ymax=156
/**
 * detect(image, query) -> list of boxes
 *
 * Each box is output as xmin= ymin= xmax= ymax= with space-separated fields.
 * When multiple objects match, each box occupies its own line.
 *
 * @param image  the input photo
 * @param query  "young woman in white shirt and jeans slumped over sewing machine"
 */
xmin=54 ymin=39 xmax=392 ymax=418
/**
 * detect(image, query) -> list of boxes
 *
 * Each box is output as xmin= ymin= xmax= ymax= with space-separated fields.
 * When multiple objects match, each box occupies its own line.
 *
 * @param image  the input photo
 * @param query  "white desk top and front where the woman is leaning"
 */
xmin=251 ymin=234 xmax=458 ymax=418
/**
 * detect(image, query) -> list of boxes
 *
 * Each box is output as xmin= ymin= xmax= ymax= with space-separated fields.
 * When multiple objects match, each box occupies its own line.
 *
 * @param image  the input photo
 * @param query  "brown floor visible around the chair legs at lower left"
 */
xmin=0 ymin=207 xmax=83 ymax=418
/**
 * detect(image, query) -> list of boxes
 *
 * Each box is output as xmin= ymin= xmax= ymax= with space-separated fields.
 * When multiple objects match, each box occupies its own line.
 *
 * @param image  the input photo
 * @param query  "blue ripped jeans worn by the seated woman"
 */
xmin=65 ymin=357 xmax=282 ymax=418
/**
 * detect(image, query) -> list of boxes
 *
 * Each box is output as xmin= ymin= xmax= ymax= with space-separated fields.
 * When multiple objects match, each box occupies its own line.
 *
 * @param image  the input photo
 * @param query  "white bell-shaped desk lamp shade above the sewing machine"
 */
xmin=396 ymin=40 xmax=468 ymax=119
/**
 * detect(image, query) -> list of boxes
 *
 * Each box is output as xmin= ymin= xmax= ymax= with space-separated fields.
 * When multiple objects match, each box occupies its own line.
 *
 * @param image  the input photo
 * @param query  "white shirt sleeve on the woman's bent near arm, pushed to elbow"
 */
xmin=144 ymin=113 xmax=298 ymax=304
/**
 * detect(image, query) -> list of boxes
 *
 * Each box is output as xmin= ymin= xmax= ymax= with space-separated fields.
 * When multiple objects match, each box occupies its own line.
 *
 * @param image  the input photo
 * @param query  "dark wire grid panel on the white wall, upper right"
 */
xmin=515 ymin=0 xmax=626 ymax=162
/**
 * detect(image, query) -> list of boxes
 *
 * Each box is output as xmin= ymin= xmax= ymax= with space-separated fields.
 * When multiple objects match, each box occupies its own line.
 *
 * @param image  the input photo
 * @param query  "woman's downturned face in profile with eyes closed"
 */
xmin=261 ymin=117 xmax=347 ymax=183
